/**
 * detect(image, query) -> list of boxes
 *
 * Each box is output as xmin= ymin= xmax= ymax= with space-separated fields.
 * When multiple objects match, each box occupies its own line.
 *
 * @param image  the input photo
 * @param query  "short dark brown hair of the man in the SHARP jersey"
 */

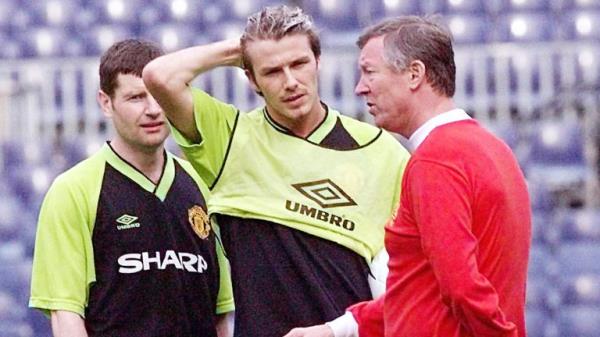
xmin=99 ymin=39 xmax=164 ymax=97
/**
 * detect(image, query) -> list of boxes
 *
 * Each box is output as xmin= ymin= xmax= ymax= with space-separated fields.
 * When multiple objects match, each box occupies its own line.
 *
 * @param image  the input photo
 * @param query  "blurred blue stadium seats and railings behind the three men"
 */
xmin=0 ymin=0 xmax=600 ymax=337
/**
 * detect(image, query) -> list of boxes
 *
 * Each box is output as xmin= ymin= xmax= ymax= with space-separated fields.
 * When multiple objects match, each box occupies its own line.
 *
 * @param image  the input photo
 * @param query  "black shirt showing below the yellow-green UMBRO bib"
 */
xmin=217 ymin=214 xmax=371 ymax=337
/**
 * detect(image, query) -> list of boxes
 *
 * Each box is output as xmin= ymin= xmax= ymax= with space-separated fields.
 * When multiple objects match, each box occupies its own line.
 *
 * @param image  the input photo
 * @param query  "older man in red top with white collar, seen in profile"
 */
xmin=287 ymin=16 xmax=531 ymax=337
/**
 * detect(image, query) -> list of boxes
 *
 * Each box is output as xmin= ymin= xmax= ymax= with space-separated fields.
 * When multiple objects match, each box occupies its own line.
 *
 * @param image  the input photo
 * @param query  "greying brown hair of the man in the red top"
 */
xmin=356 ymin=16 xmax=456 ymax=97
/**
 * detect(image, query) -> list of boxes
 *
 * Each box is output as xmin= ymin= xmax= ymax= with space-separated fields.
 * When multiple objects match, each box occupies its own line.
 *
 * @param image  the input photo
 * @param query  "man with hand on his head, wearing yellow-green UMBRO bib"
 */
xmin=143 ymin=6 xmax=408 ymax=337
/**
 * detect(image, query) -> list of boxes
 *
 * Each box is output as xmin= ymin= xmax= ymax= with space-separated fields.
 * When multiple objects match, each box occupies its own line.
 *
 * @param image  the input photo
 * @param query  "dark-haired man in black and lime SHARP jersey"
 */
xmin=29 ymin=40 xmax=233 ymax=336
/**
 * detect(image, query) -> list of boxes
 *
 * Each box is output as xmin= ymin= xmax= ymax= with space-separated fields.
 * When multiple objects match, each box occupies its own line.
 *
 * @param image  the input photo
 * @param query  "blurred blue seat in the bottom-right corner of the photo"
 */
xmin=558 ymin=306 xmax=600 ymax=337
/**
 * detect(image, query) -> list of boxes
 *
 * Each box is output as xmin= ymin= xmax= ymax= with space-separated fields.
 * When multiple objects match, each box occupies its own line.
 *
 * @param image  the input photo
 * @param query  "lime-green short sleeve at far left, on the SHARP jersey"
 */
xmin=29 ymin=177 xmax=96 ymax=317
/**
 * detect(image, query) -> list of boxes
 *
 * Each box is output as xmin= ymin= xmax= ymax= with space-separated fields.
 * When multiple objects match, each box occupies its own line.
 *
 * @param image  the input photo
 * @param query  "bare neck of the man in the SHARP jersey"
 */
xmin=110 ymin=138 xmax=165 ymax=184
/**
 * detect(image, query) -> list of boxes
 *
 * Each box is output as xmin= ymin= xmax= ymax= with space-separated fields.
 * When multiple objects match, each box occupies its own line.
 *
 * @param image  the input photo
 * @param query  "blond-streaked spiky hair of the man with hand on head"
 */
xmin=240 ymin=5 xmax=321 ymax=72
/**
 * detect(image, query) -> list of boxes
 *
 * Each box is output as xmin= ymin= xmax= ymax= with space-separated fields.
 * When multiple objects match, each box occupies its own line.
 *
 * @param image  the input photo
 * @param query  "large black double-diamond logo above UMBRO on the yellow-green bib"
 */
xmin=292 ymin=179 xmax=356 ymax=208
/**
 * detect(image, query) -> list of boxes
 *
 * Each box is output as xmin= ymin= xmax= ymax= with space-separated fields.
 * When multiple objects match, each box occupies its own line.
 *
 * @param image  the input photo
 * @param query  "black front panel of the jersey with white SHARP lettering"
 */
xmin=86 ymin=162 xmax=219 ymax=336
